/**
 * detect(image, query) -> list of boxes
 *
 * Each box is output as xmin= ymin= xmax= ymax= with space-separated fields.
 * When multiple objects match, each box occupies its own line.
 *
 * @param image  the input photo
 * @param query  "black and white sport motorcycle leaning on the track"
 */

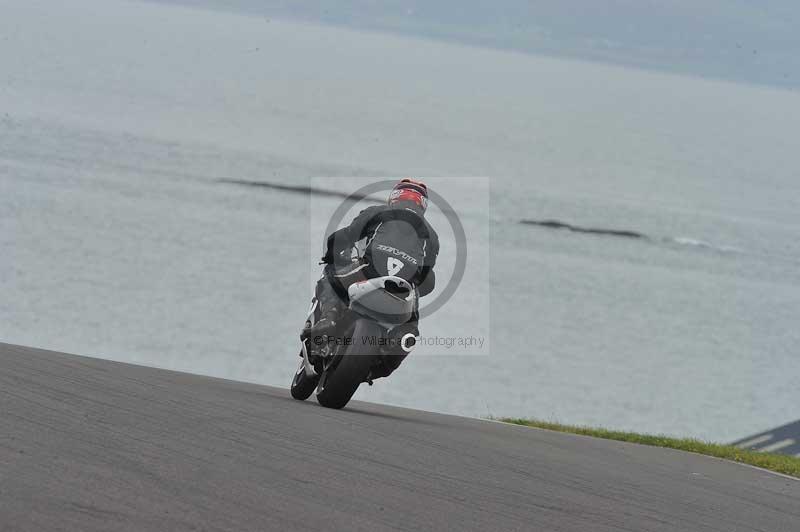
xmin=291 ymin=275 xmax=419 ymax=409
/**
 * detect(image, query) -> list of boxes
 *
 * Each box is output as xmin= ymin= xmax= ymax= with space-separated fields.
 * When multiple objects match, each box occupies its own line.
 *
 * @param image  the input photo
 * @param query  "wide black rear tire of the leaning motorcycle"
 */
xmin=317 ymin=319 xmax=384 ymax=409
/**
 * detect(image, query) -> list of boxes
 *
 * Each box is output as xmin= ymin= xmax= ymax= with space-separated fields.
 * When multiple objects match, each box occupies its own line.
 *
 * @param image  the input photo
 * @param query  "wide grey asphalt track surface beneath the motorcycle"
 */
xmin=0 ymin=344 xmax=800 ymax=532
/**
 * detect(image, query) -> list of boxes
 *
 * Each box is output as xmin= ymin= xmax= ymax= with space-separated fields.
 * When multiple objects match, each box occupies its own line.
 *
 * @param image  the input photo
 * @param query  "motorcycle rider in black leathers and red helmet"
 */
xmin=300 ymin=178 xmax=439 ymax=379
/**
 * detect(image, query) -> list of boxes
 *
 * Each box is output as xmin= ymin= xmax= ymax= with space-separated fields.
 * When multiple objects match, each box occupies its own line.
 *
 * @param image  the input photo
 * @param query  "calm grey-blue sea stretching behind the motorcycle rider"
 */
xmin=0 ymin=0 xmax=800 ymax=441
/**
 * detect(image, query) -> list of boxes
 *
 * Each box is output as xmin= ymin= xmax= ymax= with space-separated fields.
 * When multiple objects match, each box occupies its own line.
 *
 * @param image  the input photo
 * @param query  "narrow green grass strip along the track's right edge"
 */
xmin=497 ymin=418 xmax=800 ymax=478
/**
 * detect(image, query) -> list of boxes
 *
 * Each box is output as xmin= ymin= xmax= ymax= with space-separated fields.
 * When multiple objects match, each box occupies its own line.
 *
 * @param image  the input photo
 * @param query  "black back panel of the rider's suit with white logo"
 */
xmin=366 ymin=220 xmax=425 ymax=283
